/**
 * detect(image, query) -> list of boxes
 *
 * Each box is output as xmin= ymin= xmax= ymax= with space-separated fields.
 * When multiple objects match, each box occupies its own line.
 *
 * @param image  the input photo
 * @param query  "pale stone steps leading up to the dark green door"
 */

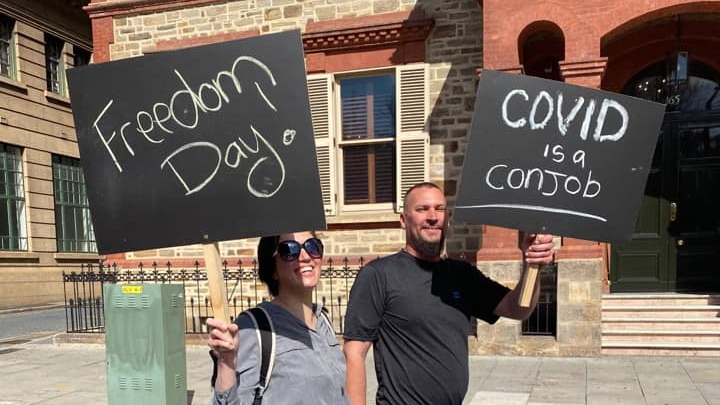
xmin=601 ymin=294 xmax=720 ymax=356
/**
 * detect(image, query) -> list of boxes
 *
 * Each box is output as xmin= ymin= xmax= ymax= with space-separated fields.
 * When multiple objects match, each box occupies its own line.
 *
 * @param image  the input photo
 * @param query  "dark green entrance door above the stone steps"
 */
xmin=610 ymin=111 xmax=720 ymax=292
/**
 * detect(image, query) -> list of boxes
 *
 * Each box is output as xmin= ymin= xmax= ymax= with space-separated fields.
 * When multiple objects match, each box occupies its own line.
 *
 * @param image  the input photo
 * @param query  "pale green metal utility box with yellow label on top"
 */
xmin=103 ymin=284 xmax=187 ymax=405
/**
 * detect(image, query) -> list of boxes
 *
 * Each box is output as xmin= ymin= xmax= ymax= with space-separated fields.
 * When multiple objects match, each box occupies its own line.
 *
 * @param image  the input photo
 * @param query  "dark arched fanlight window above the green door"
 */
xmin=622 ymin=55 xmax=720 ymax=112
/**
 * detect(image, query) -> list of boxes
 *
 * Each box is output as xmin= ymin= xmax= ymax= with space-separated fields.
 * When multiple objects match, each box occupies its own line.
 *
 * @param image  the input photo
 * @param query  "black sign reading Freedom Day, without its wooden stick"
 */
xmin=68 ymin=31 xmax=325 ymax=254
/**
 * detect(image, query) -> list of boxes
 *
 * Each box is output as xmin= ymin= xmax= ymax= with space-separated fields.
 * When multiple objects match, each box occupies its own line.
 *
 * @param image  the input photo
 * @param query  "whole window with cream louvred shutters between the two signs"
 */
xmin=308 ymin=64 xmax=429 ymax=215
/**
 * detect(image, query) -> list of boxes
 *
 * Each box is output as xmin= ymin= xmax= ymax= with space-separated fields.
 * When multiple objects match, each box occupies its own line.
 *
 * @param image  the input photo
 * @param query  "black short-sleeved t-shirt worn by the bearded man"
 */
xmin=344 ymin=251 xmax=509 ymax=405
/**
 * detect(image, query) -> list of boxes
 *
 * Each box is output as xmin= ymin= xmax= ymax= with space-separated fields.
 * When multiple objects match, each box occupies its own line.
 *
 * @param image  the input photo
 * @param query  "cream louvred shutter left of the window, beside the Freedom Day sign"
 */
xmin=307 ymin=74 xmax=337 ymax=215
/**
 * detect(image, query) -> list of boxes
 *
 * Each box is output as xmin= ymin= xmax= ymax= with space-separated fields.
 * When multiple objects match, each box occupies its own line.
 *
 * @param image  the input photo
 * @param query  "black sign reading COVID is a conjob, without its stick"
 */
xmin=454 ymin=70 xmax=665 ymax=242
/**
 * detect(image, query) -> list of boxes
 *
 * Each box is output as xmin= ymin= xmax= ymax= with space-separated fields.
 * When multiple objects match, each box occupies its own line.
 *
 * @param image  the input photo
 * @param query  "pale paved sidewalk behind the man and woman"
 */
xmin=0 ymin=332 xmax=720 ymax=405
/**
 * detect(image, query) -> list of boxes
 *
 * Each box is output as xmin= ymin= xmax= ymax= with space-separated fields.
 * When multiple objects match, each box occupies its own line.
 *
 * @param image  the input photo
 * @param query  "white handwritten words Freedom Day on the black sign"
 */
xmin=92 ymin=56 xmax=296 ymax=198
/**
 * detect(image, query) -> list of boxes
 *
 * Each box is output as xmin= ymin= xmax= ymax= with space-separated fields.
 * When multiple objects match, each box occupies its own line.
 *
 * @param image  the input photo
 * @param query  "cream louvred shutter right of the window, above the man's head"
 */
xmin=395 ymin=63 xmax=430 ymax=212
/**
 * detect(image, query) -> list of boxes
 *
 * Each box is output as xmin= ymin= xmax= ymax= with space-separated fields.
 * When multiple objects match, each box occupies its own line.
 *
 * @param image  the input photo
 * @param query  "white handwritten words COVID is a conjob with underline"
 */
xmin=472 ymin=84 xmax=629 ymax=221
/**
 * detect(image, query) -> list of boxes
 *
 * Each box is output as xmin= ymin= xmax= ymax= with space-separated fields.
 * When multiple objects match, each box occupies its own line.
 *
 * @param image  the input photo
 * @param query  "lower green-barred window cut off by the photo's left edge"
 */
xmin=0 ymin=143 xmax=27 ymax=250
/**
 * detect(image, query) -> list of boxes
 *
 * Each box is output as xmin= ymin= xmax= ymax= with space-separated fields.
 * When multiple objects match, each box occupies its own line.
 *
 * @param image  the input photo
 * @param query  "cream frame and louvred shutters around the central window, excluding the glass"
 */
xmin=307 ymin=62 xmax=430 ymax=218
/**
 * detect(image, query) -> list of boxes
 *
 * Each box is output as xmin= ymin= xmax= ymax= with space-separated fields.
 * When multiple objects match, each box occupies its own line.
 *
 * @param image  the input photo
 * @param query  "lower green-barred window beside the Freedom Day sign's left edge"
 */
xmin=53 ymin=155 xmax=97 ymax=253
